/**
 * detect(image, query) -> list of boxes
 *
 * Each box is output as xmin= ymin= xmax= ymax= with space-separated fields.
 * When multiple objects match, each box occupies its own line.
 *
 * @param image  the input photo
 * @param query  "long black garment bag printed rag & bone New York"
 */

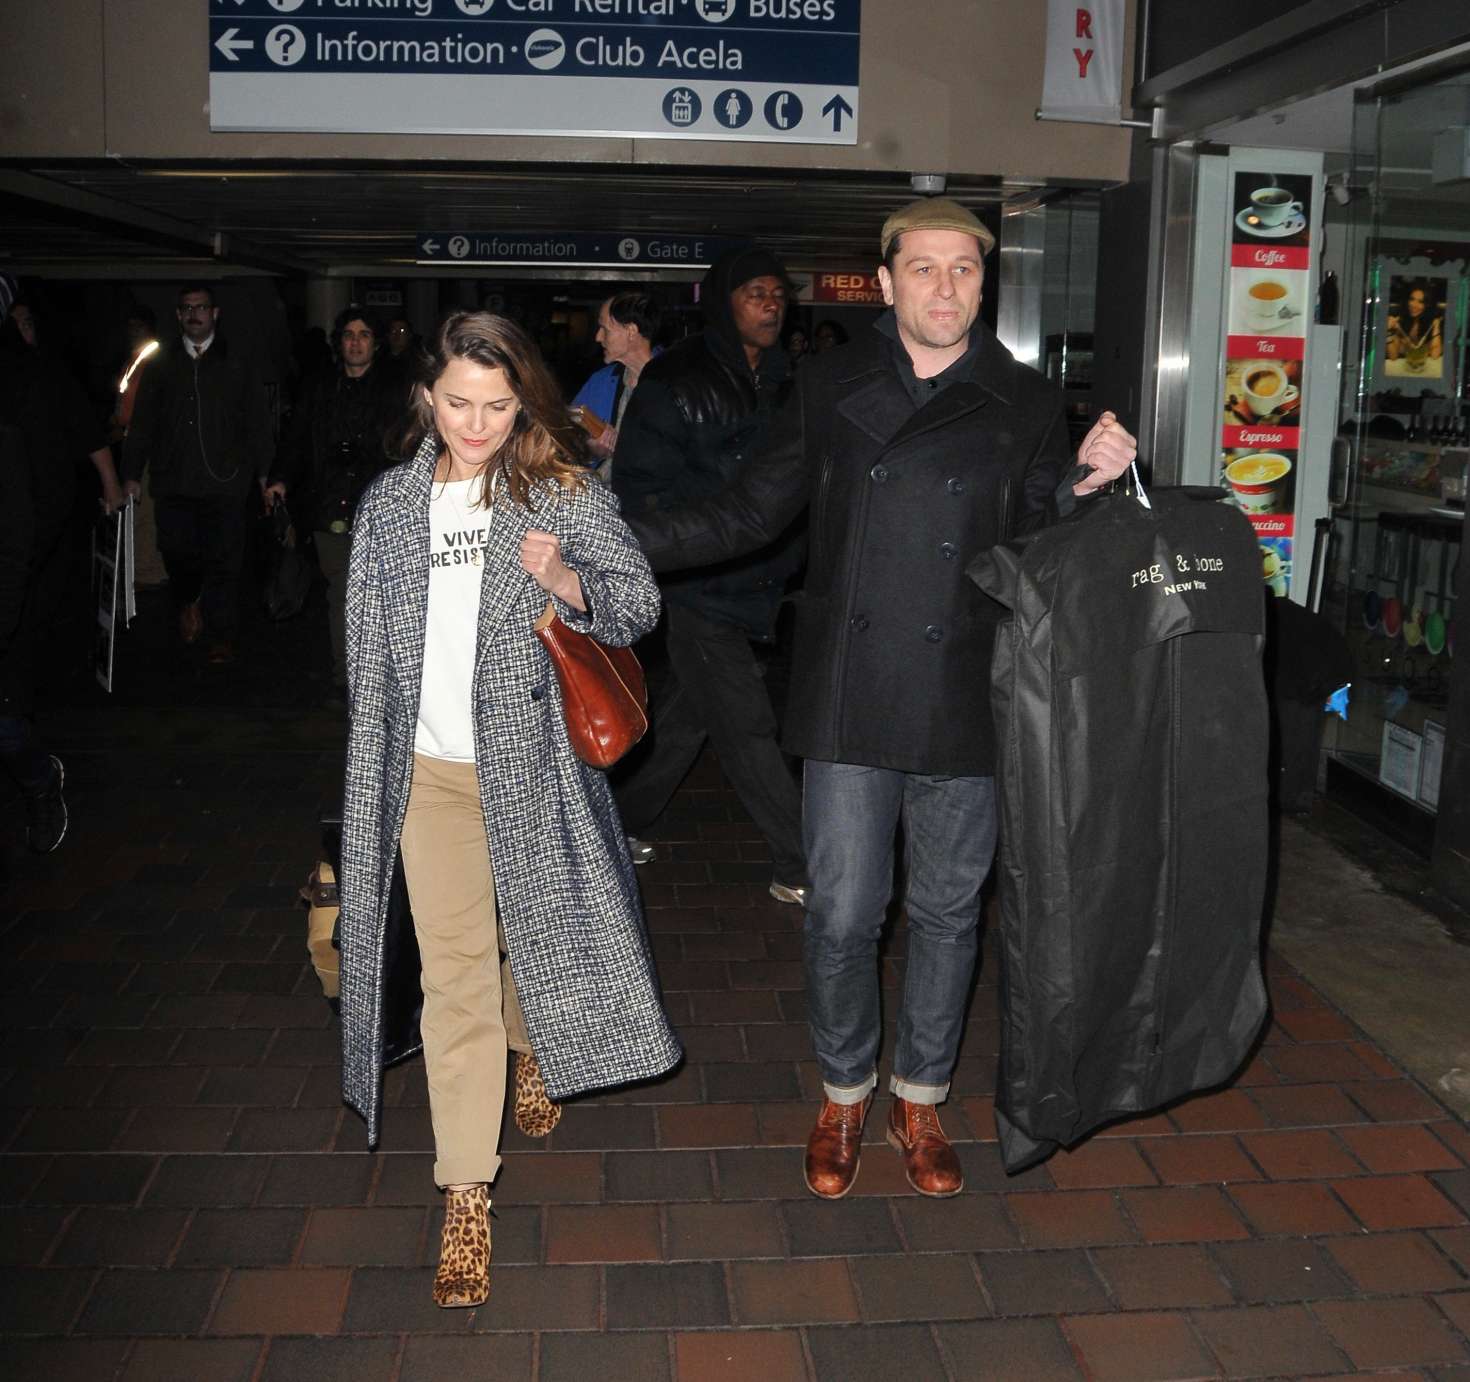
xmin=970 ymin=490 xmax=1267 ymax=1172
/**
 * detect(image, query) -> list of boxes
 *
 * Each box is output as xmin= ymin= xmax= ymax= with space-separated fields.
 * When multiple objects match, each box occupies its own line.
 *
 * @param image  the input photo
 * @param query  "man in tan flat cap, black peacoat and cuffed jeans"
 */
xmin=631 ymin=198 xmax=1135 ymax=1198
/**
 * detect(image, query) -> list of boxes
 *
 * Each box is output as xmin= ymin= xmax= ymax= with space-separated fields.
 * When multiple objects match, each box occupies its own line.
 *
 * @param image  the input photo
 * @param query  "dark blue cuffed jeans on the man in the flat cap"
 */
xmin=803 ymin=760 xmax=997 ymax=1104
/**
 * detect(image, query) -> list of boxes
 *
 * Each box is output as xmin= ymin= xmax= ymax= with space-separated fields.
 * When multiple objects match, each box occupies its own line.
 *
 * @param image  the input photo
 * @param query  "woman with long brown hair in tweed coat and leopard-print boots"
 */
xmin=341 ymin=313 xmax=681 ymax=1306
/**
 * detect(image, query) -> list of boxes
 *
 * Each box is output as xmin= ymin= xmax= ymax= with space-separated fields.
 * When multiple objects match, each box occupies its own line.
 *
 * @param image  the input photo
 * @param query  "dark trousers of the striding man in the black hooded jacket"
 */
xmin=613 ymin=606 xmax=807 ymax=887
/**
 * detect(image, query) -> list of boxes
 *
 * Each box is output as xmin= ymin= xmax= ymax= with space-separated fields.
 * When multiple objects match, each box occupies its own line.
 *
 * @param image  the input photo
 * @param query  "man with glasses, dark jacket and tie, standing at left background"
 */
xmin=123 ymin=285 xmax=272 ymax=663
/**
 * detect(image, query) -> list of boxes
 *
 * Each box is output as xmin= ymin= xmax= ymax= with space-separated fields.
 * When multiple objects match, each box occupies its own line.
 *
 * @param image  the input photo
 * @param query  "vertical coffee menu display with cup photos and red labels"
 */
xmin=1220 ymin=172 xmax=1313 ymax=595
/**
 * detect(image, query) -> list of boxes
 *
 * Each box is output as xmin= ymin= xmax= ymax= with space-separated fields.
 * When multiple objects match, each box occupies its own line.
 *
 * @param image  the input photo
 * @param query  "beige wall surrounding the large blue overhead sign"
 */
xmin=0 ymin=0 xmax=1133 ymax=182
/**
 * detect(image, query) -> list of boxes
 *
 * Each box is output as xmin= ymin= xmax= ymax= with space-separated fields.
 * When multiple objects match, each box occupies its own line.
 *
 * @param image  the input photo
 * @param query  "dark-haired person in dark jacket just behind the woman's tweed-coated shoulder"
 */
xmin=266 ymin=306 xmax=409 ymax=692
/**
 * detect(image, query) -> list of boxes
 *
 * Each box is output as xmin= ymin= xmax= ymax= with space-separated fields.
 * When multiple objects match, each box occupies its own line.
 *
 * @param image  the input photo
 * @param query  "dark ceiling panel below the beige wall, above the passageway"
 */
xmin=0 ymin=162 xmax=1070 ymax=272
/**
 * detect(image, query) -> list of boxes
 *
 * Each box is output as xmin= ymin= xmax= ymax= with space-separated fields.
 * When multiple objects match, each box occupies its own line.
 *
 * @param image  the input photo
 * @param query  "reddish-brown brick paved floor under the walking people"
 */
xmin=0 ymin=709 xmax=1470 ymax=1382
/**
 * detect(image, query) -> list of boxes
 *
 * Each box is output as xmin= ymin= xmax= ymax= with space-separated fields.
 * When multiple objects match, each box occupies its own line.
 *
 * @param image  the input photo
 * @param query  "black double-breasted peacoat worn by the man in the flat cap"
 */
xmin=629 ymin=318 xmax=1069 ymax=776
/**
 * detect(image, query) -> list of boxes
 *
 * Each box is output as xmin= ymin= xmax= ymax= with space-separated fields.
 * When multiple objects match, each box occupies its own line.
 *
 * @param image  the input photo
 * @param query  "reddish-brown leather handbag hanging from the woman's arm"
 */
xmin=532 ymin=600 xmax=648 ymax=767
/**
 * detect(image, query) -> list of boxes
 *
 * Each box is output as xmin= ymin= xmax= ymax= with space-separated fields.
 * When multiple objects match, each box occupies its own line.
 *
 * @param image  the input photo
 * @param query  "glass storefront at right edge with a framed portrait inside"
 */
xmin=1322 ymin=69 xmax=1470 ymax=854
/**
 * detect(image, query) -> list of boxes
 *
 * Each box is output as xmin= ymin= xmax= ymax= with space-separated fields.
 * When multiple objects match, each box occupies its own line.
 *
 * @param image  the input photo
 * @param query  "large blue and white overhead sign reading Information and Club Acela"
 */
xmin=209 ymin=0 xmax=861 ymax=144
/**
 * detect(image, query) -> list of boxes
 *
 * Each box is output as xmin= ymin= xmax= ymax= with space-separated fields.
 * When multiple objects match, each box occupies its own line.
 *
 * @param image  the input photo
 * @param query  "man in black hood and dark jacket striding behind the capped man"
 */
xmin=612 ymin=246 xmax=807 ymax=903
